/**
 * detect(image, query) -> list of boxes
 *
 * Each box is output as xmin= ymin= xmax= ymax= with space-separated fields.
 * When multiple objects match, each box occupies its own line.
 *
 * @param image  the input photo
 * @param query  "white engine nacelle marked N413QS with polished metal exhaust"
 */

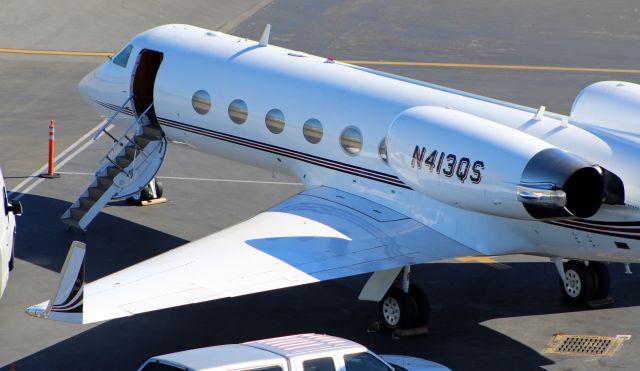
xmin=386 ymin=106 xmax=604 ymax=219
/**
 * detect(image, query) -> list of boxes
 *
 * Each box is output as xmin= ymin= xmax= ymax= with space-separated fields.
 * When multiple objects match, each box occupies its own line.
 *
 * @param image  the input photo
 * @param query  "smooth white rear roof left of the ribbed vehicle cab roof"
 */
xmin=151 ymin=344 xmax=282 ymax=371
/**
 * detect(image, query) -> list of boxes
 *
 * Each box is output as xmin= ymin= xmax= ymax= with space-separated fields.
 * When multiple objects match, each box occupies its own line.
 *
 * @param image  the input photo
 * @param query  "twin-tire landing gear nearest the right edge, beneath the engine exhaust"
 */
xmin=556 ymin=260 xmax=611 ymax=304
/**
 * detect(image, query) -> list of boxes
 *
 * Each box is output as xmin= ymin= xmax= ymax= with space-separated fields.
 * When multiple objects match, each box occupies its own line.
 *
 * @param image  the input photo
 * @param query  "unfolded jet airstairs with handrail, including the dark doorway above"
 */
xmin=62 ymin=49 xmax=167 ymax=230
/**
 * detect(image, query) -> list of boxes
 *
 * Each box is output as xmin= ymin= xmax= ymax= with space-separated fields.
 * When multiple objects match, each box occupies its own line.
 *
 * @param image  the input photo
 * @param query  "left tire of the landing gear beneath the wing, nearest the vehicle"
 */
xmin=379 ymin=287 xmax=417 ymax=330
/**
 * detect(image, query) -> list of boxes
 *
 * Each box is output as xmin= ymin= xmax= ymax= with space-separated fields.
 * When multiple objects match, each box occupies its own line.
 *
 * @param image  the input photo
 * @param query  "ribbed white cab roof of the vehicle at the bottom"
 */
xmin=243 ymin=334 xmax=367 ymax=359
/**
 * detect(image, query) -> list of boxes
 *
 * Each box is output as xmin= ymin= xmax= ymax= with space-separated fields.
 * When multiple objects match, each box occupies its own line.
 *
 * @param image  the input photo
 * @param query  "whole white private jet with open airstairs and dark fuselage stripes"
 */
xmin=27 ymin=24 xmax=640 ymax=328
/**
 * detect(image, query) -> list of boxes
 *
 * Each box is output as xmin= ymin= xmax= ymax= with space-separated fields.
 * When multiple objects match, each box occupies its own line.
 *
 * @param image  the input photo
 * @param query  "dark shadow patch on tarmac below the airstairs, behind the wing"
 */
xmin=15 ymin=194 xmax=188 ymax=281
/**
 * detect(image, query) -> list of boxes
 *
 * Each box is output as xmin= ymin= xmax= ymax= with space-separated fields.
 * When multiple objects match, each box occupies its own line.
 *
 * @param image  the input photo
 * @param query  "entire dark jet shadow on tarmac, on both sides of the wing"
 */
xmin=8 ymin=196 xmax=640 ymax=370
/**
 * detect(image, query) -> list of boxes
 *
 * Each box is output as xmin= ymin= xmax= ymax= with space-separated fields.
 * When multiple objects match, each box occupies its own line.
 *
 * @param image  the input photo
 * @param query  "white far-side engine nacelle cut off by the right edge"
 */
xmin=571 ymin=81 xmax=640 ymax=126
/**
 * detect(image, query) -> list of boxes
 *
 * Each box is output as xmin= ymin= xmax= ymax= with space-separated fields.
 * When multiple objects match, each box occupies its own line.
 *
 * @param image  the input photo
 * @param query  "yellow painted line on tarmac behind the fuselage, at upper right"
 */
xmin=341 ymin=60 xmax=640 ymax=73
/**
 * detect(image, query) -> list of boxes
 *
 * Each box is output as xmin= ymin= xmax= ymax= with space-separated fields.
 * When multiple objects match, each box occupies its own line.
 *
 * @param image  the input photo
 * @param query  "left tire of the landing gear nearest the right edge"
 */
xmin=560 ymin=260 xmax=596 ymax=304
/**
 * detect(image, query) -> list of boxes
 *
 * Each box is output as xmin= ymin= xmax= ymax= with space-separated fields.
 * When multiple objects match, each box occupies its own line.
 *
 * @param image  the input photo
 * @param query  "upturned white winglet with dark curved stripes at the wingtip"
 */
xmin=26 ymin=241 xmax=86 ymax=323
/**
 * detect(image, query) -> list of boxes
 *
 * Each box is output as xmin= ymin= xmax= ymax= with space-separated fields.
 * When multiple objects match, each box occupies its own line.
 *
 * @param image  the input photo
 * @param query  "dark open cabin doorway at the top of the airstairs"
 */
xmin=131 ymin=49 xmax=163 ymax=125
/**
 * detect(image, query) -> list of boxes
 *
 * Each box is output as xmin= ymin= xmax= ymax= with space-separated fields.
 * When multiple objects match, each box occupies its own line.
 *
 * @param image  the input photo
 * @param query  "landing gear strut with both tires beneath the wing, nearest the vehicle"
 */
xmin=378 ymin=266 xmax=430 ymax=330
